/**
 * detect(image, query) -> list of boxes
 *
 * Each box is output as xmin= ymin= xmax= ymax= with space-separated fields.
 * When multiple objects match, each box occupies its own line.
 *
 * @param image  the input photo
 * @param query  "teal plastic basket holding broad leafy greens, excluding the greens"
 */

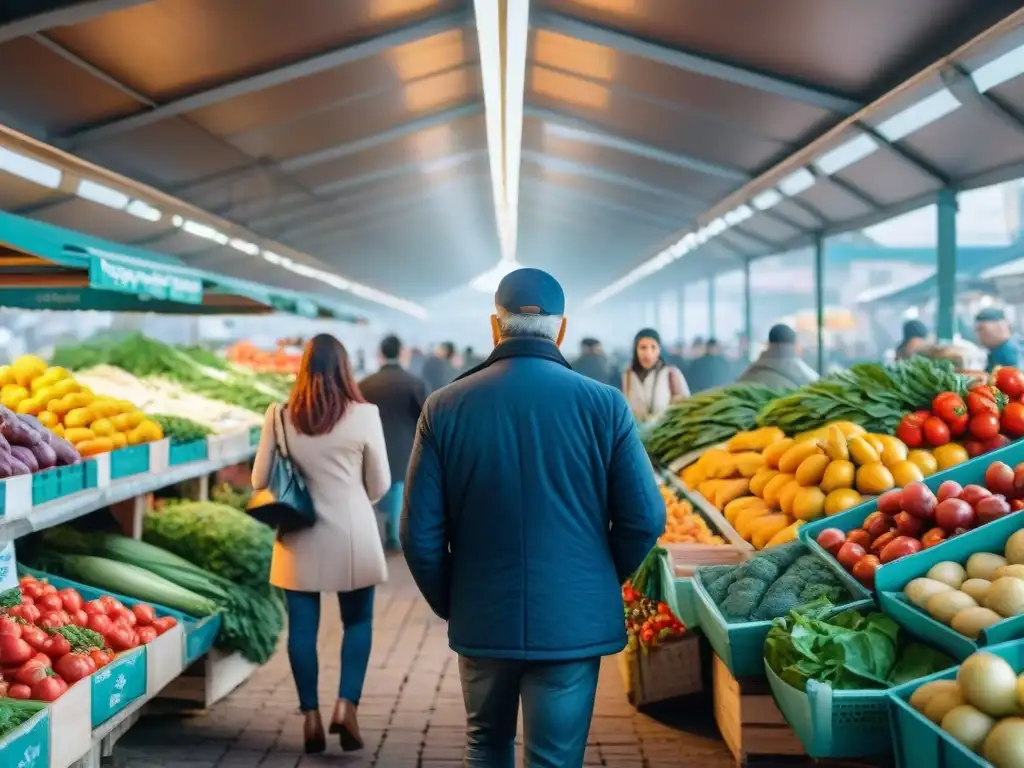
xmin=765 ymin=600 xmax=954 ymax=759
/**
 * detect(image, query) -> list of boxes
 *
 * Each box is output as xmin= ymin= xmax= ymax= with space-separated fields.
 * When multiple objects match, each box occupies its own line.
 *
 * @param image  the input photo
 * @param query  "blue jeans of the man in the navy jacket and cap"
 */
xmin=459 ymin=656 xmax=601 ymax=768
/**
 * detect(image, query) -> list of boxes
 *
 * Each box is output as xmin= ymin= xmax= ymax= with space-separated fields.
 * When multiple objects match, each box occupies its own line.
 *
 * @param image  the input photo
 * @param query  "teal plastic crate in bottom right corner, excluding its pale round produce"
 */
xmin=889 ymin=640 xmax=1024 ymax=768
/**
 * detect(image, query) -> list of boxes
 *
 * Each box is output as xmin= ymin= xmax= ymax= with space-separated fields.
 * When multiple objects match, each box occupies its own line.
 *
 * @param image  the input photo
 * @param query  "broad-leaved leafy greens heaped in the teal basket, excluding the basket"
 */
xmin=765 ymin=597 xmax=954 ymax=690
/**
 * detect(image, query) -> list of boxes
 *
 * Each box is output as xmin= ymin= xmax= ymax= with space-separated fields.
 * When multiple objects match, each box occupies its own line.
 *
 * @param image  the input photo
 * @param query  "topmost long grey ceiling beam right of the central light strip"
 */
xmin=532 ymin=11 xmax=864 ymax=116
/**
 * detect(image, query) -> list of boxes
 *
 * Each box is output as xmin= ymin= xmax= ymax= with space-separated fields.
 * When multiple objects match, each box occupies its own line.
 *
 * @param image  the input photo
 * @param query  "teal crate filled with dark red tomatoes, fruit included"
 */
xmin=800 ymin=442 xmax=1024 ymax=596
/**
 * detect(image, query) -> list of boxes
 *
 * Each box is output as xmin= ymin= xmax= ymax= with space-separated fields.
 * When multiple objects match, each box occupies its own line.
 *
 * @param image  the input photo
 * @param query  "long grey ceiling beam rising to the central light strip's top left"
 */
xmin=60 ymin=11 xmax=470 ymax=148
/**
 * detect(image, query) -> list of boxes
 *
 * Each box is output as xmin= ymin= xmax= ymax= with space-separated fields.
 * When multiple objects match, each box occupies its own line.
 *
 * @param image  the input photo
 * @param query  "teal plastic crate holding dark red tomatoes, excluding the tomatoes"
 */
xmin=800 ymin=440 xmax=1024 ymax=597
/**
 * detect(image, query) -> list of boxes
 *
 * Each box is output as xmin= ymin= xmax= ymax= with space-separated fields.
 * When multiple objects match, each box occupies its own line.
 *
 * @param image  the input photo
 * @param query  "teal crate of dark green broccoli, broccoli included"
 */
xmin=693 ymin=542 xmax=852 ymax=678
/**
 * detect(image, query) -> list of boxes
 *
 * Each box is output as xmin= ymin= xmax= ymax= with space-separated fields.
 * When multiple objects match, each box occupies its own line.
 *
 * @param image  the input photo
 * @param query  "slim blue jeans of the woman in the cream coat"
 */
xmin=285 ymin=587 xmax=374 ymax=712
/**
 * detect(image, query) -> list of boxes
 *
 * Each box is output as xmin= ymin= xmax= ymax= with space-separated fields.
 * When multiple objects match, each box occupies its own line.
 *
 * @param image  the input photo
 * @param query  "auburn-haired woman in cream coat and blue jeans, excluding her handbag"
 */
xmin=252 ymin=334 xmax=391 ymax=753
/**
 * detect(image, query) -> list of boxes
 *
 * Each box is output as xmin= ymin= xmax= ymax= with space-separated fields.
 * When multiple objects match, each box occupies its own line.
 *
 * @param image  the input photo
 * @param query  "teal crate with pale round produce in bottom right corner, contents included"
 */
xmin=889 ymin=641 xmax=1024 ymax=768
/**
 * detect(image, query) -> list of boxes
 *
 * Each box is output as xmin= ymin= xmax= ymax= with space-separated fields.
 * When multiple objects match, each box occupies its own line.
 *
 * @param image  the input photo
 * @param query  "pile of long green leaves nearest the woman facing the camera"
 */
xmin=645 ymin=384 xmax=784 ymax=467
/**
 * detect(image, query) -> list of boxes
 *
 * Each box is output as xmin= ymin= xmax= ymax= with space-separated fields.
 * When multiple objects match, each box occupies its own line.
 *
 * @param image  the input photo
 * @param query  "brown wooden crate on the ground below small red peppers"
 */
xmin=618 ymin=634 xmax=703 ymax=707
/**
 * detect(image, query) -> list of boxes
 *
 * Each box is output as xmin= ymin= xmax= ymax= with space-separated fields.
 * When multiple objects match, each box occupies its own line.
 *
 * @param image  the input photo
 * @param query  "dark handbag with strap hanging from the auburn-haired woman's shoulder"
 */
xmin=247 ymin=406 xmax=316 ymax=534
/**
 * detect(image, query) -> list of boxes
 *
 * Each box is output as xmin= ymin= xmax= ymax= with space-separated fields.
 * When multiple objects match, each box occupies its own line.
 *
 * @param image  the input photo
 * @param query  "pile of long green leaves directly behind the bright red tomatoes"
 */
xmin=757 ymin=355 xmax=968 ymax=435
